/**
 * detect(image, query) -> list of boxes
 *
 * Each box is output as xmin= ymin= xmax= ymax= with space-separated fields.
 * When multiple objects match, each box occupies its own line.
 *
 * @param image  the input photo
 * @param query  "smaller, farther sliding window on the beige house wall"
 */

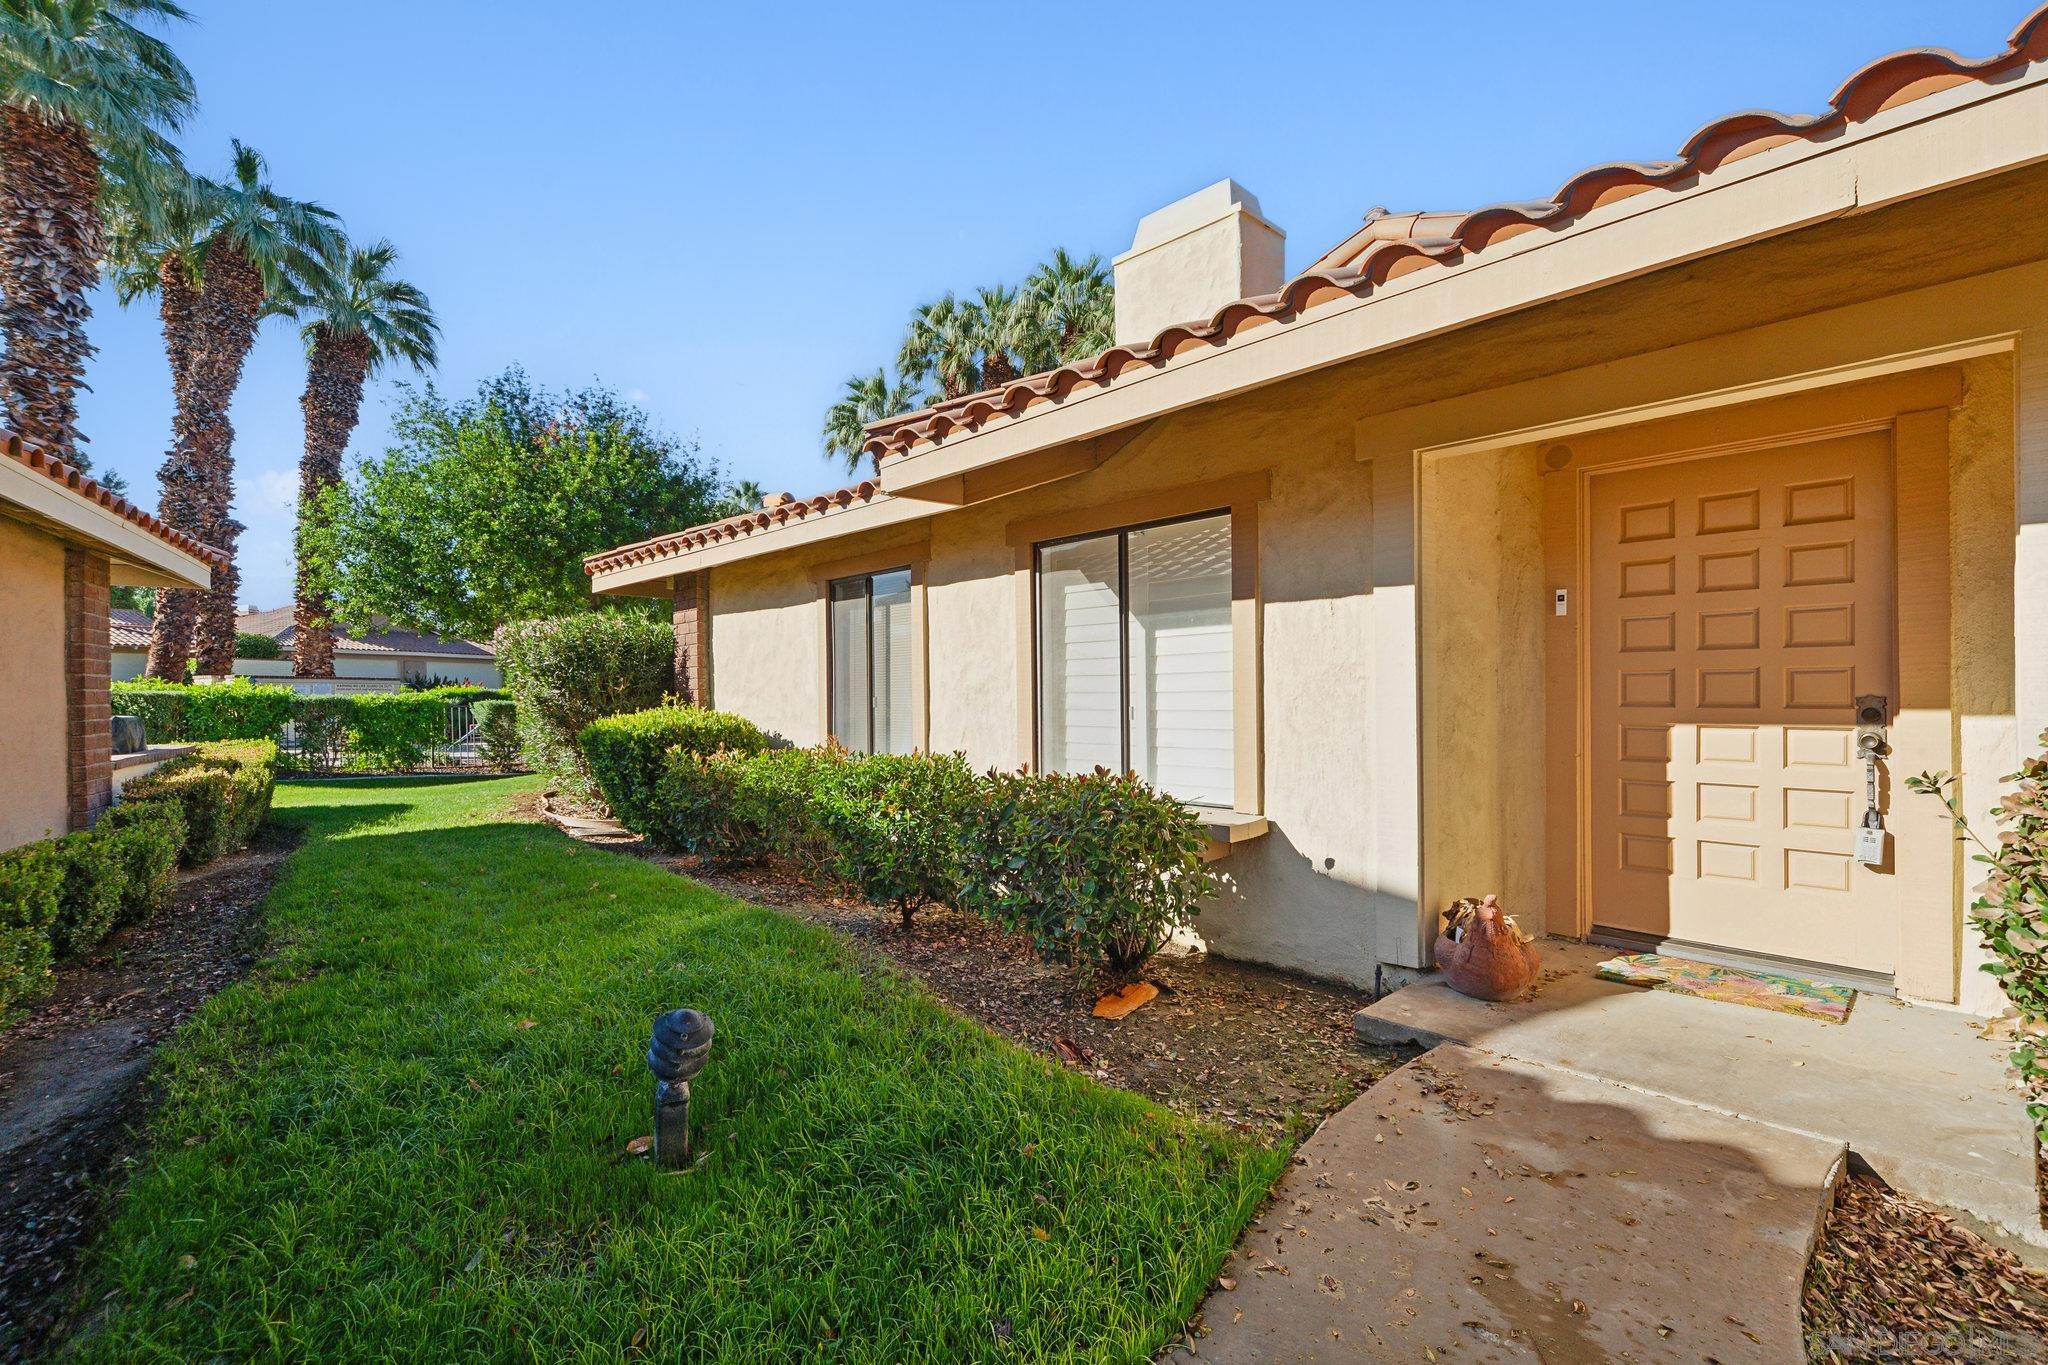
xmin=827 ymin=569 xmax=915 ymax=753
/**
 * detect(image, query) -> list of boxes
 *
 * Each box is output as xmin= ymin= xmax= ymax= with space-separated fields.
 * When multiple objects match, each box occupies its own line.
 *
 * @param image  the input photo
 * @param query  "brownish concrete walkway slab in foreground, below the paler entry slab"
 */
xmin=1174 ymin=1044 xmax=1843 ymax=1365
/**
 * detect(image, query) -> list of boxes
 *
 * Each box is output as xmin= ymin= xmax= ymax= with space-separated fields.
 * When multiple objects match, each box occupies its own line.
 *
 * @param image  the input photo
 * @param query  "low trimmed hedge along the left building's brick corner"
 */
xmin=0 ymin=741 xmax=276 ymax=1013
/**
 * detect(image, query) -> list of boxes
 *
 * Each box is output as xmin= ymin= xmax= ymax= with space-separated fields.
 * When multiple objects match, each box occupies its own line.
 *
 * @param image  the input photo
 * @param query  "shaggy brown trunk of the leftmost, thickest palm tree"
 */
xmin=0 ymin=106 xmax=106 ymax=460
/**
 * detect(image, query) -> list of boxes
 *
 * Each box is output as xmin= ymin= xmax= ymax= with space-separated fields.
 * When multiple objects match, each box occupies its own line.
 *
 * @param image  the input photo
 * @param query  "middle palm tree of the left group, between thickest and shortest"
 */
xmin=135 ymin=141 xmax=346 ymax=677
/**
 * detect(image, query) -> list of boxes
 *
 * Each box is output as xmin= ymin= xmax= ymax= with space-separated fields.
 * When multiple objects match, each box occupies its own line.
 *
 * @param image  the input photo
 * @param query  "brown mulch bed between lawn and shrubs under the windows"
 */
xmin=537 ymin=794 xmax=1415 ymax=1142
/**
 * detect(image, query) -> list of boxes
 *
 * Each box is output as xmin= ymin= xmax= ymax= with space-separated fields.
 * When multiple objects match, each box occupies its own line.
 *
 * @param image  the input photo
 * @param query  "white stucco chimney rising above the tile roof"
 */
xmin=1112 ymin=180 xmax=1286 ymax=344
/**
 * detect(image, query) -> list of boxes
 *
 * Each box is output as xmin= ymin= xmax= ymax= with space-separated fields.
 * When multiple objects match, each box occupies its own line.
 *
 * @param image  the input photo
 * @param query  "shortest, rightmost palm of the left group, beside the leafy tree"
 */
xmin=287 ymin=241 xmax=440 ymax=677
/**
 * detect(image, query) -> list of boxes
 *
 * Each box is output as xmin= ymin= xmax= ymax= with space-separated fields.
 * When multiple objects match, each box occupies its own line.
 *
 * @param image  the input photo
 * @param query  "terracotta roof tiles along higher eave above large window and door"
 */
xmin=866 ymin=4 xmax=2048 ymax=458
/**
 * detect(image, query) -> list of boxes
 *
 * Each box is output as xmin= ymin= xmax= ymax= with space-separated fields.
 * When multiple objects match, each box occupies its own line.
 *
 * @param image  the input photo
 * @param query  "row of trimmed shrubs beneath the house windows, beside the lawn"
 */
xmin=610 ymin=708 xmax=1214 ymax=974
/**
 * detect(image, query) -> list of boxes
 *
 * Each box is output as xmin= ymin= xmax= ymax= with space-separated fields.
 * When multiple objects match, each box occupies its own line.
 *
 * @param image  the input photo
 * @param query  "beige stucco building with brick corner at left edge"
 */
xmin=0 ymin=434 xmax=219 ymax=849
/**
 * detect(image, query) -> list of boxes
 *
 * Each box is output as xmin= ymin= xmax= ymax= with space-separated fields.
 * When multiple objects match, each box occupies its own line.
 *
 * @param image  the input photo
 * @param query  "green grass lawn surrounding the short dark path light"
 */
xmin=72 ymin=778 xmax=1284 ymax=1361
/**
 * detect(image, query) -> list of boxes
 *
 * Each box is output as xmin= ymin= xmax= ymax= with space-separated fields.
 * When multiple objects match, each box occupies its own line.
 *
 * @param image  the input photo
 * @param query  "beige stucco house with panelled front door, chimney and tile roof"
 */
xmin=586 ymin=18 xmax=2048 ymax=1007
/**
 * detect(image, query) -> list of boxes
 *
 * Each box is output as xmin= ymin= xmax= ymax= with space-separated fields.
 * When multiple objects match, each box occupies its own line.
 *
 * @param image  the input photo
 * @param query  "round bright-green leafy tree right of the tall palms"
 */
xmin=301 ymin=366 xmax=725 ymax=639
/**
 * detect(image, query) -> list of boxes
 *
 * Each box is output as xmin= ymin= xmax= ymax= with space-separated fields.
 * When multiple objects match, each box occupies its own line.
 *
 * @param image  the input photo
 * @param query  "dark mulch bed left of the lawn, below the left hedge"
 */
xmin=0 ymin=829 xmax=291 ymax=1361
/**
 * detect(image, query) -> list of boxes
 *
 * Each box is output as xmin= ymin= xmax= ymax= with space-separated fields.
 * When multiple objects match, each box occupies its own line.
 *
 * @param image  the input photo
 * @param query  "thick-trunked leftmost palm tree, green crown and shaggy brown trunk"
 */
xmin=0 ymin=0 xmax=193 ymax=467
